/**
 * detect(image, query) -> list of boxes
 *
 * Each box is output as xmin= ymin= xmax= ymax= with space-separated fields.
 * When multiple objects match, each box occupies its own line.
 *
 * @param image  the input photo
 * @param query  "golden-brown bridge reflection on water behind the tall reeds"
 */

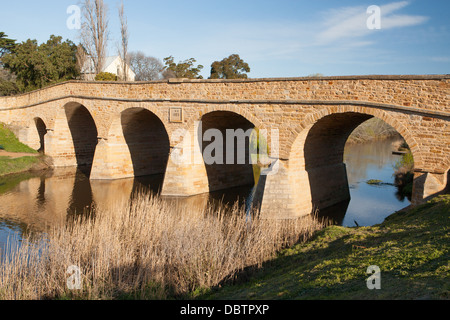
xmin=0 ymin=167 xmax=253 ymax=232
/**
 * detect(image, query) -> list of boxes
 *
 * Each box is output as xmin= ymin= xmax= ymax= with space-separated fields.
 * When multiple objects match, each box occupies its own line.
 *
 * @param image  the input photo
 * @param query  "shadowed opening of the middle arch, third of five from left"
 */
xmin=121 ymin=108 xmax=170 ymax=181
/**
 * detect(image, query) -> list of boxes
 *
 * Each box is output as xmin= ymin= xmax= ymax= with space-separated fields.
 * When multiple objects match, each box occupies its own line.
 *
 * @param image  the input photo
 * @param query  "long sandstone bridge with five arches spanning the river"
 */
xmin=0 ymin=75 xmax=450 ymax=218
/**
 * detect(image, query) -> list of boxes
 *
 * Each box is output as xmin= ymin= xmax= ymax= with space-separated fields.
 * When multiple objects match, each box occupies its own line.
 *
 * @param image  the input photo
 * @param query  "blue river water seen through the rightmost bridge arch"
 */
xmin=322 ymin=138 xmax=411 ymax=227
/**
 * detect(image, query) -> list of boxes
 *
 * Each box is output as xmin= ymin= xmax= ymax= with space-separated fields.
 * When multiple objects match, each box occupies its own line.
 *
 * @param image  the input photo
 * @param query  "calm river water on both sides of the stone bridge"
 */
xmin=0 ymin=140 xmax=410 ymax=255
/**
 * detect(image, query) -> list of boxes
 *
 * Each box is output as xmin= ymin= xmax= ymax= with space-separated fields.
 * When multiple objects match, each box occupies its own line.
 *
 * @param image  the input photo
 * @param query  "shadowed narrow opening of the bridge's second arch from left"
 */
xmin=65 ymin=103 xmax=98 ymax=174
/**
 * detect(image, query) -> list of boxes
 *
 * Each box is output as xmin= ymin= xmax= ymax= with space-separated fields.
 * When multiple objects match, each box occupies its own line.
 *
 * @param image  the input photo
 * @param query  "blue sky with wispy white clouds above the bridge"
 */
xmin=0 ymin=0 xmax=450 ymax=78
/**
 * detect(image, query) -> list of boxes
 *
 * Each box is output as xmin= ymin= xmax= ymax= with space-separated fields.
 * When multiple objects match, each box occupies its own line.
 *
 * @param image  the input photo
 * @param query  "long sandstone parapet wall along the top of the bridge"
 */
xmin=0 ymin=75 xmax=450 ymax=113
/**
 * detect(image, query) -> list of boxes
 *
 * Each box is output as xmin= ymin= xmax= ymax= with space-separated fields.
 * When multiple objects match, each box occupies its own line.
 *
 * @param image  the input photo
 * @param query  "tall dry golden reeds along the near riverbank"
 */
xmin=0 ymin=194 xmax=322 ymax=300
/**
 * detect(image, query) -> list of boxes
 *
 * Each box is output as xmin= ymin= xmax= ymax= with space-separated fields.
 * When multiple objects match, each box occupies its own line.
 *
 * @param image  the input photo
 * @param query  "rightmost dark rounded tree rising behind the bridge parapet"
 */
xmin=210 ymin=54 xmax=250 ymax=79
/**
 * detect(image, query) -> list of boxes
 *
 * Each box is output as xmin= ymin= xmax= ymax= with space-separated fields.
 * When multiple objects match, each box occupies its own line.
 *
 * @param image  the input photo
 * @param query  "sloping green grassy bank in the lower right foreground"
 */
xmin=203 ymin=195 xmax=450 ymax=299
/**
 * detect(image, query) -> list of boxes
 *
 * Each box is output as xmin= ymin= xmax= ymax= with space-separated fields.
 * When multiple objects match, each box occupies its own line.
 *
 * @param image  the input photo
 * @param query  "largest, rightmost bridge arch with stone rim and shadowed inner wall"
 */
xmin=289 ymin=107 xmax=421 ymax=214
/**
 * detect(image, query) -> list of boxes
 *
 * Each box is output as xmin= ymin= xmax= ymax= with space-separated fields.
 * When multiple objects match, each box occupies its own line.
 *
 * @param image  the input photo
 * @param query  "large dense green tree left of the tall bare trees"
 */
xmin=3 ymin=35 xmax=79 ymax=92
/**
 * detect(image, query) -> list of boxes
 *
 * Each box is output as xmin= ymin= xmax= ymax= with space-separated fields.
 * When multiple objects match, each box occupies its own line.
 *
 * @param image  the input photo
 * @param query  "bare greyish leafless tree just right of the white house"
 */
xmin=127 ymin=51 xmax=164 ymax=81
